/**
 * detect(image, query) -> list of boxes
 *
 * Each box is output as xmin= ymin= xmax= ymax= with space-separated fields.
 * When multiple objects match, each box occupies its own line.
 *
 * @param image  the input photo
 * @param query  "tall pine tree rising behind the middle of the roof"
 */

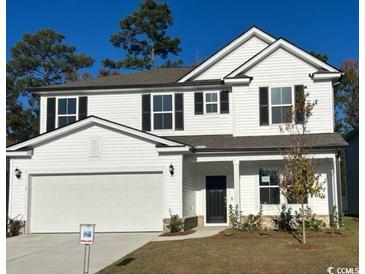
xmin=103 ymin=0 xmax=182 ymax=70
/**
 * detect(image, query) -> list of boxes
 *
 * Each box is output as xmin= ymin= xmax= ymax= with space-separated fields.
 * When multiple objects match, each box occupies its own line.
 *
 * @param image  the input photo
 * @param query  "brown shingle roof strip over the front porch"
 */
xmin=165 ymin=133 xmax=348 ymax=150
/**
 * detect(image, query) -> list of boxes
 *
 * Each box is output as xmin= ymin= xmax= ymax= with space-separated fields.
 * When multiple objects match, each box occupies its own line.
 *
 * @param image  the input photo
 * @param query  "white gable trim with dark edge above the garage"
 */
xmin=6 ymin=116 xmax=186 ymax=152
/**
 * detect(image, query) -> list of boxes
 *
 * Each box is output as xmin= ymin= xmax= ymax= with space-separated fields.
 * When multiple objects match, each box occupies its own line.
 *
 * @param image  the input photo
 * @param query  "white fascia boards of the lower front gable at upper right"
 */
xmin=225 ymin=39 xmax=339 ymax=78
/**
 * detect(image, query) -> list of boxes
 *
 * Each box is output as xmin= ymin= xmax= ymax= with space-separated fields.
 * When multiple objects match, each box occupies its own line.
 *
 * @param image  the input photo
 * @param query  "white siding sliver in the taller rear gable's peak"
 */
xmin=194 ymin=36 xmax=268 ymax=80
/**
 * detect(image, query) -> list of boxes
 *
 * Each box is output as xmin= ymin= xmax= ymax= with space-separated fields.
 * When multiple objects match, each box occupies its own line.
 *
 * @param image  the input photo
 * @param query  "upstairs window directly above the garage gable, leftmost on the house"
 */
xmin=57 ymin=98 xmax=77 ymax=127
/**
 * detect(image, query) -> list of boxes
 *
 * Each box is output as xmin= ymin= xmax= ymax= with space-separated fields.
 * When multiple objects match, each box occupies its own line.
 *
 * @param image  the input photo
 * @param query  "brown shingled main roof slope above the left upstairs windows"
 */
xmin=31 ymin=67 xmax=194 ymax=91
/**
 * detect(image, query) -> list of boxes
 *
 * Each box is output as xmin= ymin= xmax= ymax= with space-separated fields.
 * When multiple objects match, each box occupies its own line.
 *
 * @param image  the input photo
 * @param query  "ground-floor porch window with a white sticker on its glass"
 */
xmin=259 ymin=169 xmax=280 ymax=204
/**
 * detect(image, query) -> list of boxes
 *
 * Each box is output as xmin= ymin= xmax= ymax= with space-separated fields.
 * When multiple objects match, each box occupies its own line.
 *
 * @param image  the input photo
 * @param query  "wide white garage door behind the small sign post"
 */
xmin=30 ymin=173 xmax=163 ymax=233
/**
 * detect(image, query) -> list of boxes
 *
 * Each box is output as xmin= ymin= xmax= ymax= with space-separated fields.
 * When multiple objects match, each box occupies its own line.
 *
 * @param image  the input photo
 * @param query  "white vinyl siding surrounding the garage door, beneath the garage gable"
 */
xmin=9 ymin=126 xmax=182 ymax=225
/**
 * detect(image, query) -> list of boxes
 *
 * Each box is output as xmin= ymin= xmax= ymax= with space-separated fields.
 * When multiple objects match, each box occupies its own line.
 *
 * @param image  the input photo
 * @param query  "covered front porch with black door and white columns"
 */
xmin=183 ymin=152 xmax=341 ymax=226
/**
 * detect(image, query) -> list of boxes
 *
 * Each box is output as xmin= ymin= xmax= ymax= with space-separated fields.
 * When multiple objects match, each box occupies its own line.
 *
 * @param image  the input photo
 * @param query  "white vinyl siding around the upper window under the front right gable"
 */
xmin=232 ymin=49 xmax=333 ymax=136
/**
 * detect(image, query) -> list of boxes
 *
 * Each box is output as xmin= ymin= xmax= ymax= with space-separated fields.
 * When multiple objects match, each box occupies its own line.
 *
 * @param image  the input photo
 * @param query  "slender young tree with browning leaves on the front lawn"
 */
xmin=280 ymin=87 xmax=324 ymax=244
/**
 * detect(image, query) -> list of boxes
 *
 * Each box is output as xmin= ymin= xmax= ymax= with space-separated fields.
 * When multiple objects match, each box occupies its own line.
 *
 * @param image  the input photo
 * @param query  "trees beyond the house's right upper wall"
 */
xmin=335 ymin=60 xmax=359 ymax=134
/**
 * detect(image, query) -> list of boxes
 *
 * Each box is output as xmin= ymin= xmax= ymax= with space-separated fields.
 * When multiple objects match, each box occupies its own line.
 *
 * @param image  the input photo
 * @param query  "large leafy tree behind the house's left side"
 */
xmin=6 ymin=29 xmax=94 ymax=141
